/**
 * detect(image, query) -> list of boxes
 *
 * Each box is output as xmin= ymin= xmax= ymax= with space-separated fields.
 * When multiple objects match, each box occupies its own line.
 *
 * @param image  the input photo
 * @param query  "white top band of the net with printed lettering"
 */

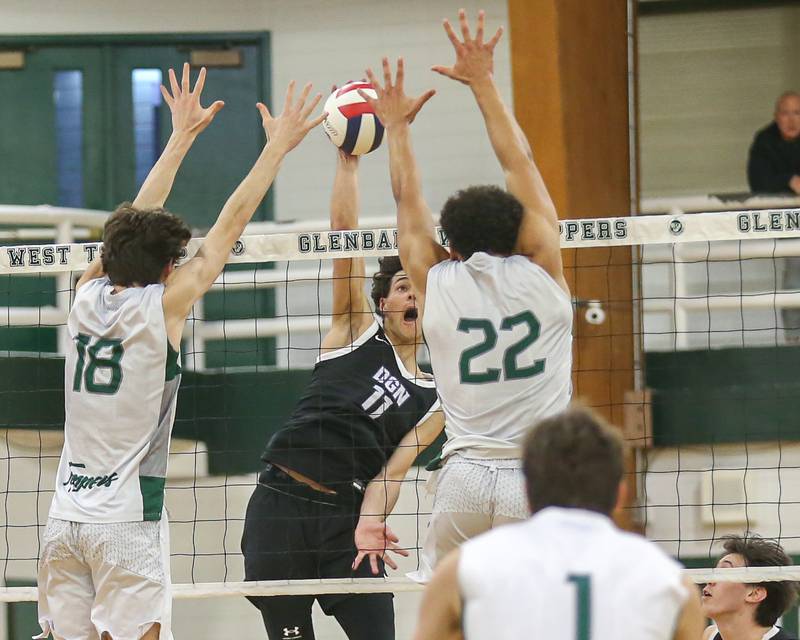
xmin=0 ymin=209 xmax=800 ymax=274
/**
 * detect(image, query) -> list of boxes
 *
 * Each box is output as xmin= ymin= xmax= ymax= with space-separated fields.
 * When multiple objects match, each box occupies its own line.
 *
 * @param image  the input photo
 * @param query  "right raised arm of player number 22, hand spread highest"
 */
xmin=432 ymin=9 xmax=567 ymax=290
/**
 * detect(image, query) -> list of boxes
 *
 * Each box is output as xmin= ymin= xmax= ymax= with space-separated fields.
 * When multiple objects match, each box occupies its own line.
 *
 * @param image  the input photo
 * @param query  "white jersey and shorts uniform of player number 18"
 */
xmin=39 ymin=278 xmax=180 ymax=638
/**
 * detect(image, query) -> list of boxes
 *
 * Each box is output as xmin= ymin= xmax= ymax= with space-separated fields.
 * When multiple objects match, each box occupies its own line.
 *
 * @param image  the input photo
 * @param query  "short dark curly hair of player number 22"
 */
xmin=439 ymin=185 xmax=522 ymax=260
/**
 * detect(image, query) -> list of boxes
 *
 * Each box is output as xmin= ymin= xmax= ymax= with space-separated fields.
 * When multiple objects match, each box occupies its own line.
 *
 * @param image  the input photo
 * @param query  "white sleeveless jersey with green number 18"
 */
xmin=50 ymin=278 xmax=180 ymax=522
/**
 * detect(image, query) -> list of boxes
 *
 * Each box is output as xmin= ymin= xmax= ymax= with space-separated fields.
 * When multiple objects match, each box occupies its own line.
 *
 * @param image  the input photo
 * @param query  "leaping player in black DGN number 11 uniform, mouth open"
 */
xmin=242 ymin=154 xmax=444 ymax=640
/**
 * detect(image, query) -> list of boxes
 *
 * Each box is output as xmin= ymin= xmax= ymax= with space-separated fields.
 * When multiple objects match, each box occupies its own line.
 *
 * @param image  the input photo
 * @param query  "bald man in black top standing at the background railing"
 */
xmin=747 ymin=91 xmax=800 ymax=344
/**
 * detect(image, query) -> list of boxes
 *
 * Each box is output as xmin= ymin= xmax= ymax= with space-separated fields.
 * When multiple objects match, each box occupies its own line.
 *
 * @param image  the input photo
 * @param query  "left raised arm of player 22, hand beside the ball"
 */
xmin=359 ymin=58 xmax=449 ymax=295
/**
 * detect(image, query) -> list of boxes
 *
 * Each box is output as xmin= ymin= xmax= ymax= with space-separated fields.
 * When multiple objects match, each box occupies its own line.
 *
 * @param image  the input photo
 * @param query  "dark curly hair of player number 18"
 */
xmin=102 ymin=202 xmax=192 ymax=287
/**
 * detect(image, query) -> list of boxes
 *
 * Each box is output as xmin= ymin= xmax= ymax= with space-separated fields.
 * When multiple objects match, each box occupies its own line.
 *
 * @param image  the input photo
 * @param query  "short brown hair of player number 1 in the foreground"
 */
xmin=523 ymin=407 xmax=624 ymax=515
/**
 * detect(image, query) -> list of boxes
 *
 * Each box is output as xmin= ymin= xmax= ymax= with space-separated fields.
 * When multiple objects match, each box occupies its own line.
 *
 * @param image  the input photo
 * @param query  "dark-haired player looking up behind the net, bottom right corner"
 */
xmin=702 ymin=535 xmax=797 ymax=640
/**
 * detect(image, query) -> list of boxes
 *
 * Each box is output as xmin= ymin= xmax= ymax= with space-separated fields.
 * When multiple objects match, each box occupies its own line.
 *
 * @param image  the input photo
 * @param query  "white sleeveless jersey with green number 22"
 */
xmin=423 ymin=252 xmax=572 ymax=457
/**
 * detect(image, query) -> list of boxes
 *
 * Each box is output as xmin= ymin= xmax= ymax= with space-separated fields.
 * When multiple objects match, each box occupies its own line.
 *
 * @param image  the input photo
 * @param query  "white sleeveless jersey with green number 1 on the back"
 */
xmin=458 ymin=507 xmax=689 ymax=640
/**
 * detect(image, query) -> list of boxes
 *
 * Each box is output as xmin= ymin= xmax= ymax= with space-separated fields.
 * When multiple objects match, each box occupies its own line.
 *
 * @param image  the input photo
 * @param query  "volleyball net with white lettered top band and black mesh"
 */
xmin=0 ymin=209 xmax=800 ymax=601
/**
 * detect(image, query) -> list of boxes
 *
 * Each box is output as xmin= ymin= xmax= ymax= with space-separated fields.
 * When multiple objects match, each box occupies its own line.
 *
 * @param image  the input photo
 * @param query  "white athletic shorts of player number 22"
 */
xmin=408 ymin=453 xmax=530 ymax=582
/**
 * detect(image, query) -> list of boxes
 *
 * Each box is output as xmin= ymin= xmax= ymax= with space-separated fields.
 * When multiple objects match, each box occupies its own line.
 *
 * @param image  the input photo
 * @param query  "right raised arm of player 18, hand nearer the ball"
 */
xmin=164 ymin=82 xmax=324 ymax=336
